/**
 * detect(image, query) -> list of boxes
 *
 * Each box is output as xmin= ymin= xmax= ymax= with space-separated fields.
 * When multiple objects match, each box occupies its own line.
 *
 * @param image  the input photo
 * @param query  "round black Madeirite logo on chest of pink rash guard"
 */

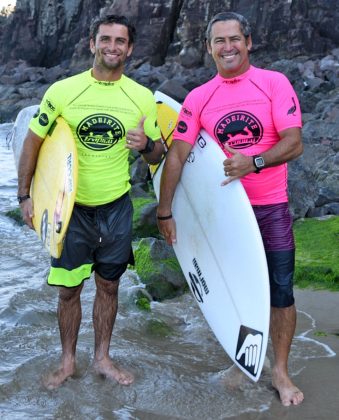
xmin=214 ymin=111 xmax=263 ymax=149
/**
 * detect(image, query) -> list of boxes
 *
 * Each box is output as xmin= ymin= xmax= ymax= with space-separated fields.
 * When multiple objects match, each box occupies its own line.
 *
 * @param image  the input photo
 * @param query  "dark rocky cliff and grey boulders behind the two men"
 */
xmin=0 ymin=0 xmax=339 ymax=217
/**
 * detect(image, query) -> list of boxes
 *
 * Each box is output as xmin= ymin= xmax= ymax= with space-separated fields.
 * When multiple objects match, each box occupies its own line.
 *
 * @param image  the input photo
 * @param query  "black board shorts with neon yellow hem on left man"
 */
xmin=47 ymin=193 xmax=134 ymax=287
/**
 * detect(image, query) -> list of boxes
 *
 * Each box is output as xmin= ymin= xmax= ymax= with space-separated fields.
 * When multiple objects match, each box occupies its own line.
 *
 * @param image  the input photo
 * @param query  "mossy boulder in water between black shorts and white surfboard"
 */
xmin=134 ymin=238 xmax=187 ymax=301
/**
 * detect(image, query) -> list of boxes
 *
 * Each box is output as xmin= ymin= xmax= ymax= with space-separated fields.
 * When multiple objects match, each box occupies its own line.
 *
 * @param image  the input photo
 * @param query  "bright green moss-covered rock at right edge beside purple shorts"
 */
xmin=293 ymin=216 xmax=339 ymax=291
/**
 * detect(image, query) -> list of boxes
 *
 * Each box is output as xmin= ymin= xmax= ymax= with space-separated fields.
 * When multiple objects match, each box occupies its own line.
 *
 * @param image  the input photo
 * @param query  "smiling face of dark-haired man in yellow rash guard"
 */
xmin=90 ymin=23 xmax=133 ymax=81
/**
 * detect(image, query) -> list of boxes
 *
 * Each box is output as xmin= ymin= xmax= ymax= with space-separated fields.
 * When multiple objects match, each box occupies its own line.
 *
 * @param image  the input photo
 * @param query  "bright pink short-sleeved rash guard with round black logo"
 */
xmin=173 ymin=66 xmax=302 ymax=205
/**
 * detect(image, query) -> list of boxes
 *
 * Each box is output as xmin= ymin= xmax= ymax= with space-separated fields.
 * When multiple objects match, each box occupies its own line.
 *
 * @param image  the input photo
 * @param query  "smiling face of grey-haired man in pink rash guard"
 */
xmin=207 ymin=20 xmax=252 ymax=78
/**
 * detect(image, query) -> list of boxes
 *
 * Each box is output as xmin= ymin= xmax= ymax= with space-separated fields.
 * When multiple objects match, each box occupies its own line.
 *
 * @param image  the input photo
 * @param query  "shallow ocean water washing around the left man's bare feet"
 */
xmin=0 ymin=120 xmax=333 ymax=420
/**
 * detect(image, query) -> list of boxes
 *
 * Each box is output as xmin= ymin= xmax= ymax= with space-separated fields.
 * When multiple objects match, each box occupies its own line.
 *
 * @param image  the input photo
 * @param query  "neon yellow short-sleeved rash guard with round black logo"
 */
xmin=29 ymin=70 xmax=160 ymax=206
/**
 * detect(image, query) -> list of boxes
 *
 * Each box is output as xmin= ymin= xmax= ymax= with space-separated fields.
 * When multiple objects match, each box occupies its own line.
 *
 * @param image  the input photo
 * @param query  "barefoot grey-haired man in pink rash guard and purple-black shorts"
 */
xmin=157 ymin=12 xmax=304 ymax=406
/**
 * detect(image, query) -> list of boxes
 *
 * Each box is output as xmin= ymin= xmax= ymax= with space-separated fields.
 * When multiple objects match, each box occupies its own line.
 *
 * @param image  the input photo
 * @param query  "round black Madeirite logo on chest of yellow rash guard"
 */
xmin=77 ymin=114 xmax=125 ymax=152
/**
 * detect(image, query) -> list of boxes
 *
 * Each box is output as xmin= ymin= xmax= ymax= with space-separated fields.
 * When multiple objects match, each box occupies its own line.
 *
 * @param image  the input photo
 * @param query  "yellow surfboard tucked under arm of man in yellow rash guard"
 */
xmin=12 ymin=106 xmax=78 ymax=258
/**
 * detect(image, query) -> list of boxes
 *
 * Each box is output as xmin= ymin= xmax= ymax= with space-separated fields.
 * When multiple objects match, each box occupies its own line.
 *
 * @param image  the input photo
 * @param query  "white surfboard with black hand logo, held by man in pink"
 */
xmin=151 ymin=92 xmax=270 ymax=381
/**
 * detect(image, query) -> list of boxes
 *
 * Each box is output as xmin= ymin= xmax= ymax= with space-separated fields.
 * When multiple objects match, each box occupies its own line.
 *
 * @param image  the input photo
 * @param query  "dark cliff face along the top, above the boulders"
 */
xmin=0 ymin=0 xmax=339 ymax=67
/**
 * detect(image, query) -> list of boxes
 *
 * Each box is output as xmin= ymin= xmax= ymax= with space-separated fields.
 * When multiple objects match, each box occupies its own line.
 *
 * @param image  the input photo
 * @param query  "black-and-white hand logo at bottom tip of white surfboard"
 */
xmin=236 ymin=325 xmax=263 ymax=376
